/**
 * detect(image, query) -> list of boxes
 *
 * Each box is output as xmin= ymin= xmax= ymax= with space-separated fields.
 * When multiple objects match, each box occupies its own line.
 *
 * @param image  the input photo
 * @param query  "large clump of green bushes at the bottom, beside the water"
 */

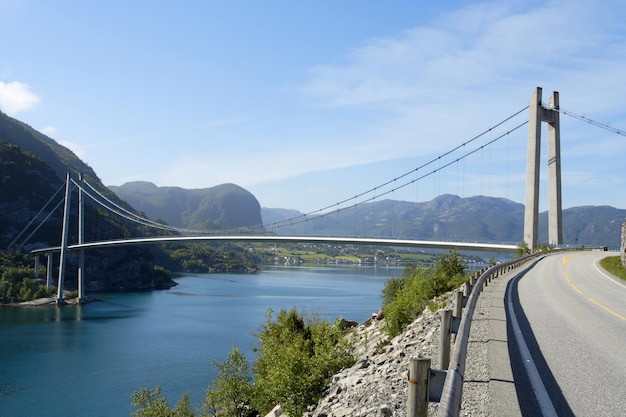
xmin=132 ymin=309 xmax=354 ymax=417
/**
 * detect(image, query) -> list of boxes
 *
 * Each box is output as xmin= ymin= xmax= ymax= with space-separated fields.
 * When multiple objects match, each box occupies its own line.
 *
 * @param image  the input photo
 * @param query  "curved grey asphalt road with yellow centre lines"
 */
xmin=506 ymin=252 xmax=626 ymax=417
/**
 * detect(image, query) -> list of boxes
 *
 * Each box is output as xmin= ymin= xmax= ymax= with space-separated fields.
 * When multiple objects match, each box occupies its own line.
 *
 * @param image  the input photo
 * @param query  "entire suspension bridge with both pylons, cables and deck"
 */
xmin=10 ymin=87 xmax=624 ymax=303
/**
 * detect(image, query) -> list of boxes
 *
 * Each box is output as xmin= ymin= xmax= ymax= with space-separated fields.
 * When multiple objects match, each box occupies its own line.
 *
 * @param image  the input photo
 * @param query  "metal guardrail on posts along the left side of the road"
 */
xmin=407 ymin=252 xmax=546 ymax=417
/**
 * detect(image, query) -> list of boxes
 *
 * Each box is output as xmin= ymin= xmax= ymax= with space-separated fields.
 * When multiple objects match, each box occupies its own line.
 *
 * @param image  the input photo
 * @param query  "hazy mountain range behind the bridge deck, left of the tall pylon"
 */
xmin=265 ymin=194 xmax=524 ymax=243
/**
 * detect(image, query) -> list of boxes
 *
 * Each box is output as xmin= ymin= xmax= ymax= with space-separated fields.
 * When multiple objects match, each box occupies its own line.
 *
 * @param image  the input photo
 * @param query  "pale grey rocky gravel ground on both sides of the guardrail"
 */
xmin=306 ymin=291 xmax=491 ymax=417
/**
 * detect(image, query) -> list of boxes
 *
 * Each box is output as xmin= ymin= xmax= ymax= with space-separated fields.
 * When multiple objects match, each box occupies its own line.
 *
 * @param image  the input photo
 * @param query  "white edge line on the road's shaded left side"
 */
xmin=506 ymin=274 xmax=558 ymax=417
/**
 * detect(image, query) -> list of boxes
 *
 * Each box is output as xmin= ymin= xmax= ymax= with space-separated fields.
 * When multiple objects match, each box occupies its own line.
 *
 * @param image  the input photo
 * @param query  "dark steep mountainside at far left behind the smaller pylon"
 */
xmin=0 ymin=112 xmax=173 ymax=291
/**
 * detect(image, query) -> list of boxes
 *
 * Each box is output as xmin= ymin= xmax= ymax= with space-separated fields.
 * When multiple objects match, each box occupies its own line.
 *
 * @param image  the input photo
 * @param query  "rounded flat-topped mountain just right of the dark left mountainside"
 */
xmin=109 ymin=181 xmax=261 ymax=230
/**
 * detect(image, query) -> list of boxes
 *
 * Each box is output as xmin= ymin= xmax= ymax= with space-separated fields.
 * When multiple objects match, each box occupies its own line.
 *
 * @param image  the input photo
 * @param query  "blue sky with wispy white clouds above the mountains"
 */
xmin=0 ymin=0 xmax=626 ymax=212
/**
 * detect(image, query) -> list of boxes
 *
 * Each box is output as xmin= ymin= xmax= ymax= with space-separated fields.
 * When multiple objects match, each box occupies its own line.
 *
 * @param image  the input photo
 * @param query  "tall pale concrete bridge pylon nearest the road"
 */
xmin=524 ymin=87 xmax=563 ymax=251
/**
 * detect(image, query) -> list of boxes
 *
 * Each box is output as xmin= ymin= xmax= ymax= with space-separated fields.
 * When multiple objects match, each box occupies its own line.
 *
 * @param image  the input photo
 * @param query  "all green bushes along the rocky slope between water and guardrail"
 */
xmin=131 ymin=251 xmax=469 ymax=417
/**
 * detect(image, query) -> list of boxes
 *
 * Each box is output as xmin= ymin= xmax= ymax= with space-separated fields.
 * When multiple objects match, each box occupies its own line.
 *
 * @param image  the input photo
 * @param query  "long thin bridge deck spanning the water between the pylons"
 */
xmin=32 ymin=235 xmax=518 ymax=255
